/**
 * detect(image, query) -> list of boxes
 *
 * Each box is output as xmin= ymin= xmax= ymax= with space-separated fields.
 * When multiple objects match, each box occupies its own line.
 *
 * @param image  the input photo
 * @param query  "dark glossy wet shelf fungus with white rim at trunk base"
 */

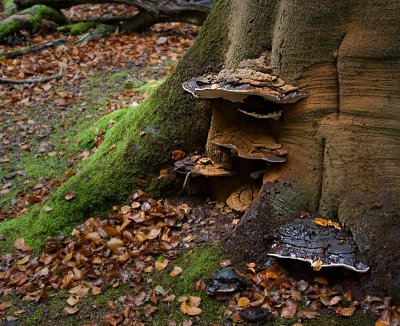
xmin=268 ymin=219 xmax=369 ymax=273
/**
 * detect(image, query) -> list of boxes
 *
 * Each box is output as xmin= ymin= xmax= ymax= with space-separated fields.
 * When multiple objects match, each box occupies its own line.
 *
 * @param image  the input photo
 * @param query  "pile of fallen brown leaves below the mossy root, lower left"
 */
xmin=0 ymin=191 xmax=196 ymax=325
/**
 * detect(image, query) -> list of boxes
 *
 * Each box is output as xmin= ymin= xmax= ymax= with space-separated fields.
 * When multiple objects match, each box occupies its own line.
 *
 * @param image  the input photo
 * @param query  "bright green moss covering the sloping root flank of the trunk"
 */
xmin=0 ymin=1 xmax=228 ymax=247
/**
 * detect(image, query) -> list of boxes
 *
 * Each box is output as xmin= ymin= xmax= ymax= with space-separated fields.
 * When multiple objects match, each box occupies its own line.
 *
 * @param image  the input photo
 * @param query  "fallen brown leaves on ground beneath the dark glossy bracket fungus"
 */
xmin=222 ymin=263 xmax=400 ymax=325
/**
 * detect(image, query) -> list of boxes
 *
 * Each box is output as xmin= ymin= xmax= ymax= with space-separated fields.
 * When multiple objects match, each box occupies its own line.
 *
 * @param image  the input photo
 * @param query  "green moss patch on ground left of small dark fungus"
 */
xmin=153 ymin=246 xmax=225 ymax=325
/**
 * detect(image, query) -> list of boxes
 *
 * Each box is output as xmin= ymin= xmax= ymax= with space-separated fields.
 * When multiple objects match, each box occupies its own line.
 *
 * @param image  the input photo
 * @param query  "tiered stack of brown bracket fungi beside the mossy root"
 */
xmin=182 ymin=66 xmax=307 ymax=212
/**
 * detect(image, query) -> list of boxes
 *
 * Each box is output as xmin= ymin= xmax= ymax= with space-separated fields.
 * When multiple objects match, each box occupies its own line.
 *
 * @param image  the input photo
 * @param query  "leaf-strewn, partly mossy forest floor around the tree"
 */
xmin=0 ymin=5 xmax=390 ymax=326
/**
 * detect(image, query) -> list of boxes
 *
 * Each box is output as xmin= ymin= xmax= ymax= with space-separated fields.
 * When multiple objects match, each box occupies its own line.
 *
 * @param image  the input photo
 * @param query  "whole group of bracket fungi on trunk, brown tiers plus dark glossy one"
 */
xmin=176 ymin=57 xmax=369 ymax=273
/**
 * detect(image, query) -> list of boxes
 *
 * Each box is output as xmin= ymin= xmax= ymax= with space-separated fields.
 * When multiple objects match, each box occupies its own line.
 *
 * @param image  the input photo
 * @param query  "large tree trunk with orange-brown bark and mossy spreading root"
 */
xmin=1 ymin=0 xmax=400 ymax=298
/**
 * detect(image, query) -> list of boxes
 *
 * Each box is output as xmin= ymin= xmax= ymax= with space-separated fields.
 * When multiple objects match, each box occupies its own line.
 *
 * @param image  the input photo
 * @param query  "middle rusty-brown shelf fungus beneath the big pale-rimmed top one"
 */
xmin=210 ymin=124 xmax=287 ymax=163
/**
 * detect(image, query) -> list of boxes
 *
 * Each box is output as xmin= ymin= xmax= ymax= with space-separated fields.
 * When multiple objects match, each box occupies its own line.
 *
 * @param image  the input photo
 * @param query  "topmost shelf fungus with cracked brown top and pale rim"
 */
xmin=182 ymin=68 xmax=307 ymax=104
